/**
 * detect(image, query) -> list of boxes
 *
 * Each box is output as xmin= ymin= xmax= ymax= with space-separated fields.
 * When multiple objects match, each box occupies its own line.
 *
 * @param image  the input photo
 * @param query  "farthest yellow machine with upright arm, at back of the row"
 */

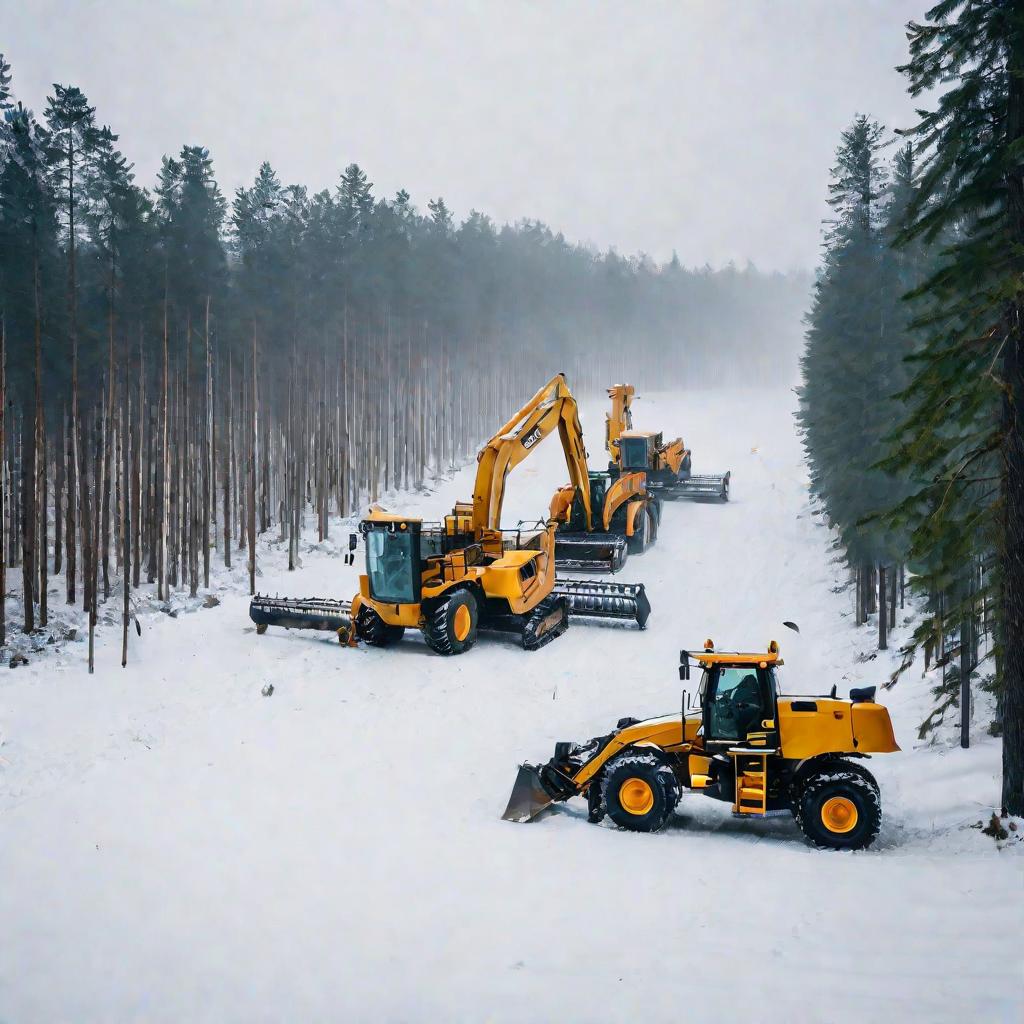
xmin=604 ymin=384 xmax=732 ymax=502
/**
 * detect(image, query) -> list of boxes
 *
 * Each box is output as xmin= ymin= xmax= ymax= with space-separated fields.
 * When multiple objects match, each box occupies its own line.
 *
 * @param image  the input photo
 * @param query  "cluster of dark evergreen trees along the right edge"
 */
xmin=799 ymin=0 xmax=1024 ymax=814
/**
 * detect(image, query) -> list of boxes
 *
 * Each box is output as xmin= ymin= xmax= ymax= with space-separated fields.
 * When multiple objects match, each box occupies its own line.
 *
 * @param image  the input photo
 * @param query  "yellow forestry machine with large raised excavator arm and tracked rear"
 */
xmin=249 ymin=375 xmax=650 ymax=654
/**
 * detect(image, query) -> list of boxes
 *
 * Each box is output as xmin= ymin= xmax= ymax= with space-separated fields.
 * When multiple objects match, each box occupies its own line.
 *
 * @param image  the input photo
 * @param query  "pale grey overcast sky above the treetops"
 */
xmin=0 ymin=0 xmax=928 ymax=269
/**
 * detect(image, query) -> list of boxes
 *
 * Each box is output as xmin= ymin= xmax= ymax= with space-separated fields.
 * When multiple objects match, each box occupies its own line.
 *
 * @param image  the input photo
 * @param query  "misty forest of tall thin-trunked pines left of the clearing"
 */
xmin=0 ymin=57 xmax=809 ymax=665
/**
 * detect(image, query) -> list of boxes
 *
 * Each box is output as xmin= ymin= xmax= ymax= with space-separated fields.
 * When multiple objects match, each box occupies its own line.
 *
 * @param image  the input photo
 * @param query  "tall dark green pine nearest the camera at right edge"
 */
xmin=891 ymin=0 xmax=1024 ymax=814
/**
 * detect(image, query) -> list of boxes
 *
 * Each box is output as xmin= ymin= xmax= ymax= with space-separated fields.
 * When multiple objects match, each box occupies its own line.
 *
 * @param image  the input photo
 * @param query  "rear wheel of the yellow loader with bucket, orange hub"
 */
xmin=794 ymin=761 xmax=882 ymax=850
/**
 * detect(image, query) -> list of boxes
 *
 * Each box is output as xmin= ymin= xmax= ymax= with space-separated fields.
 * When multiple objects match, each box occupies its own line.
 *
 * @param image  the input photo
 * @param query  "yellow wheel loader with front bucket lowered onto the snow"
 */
xmin=503 ymin=640 xmax=899 ymax=850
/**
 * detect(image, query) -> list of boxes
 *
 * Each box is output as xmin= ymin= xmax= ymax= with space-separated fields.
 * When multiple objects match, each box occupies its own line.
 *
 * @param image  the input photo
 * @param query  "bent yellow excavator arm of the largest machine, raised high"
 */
xmin=473 ymin=374 xmax=593 ymax=537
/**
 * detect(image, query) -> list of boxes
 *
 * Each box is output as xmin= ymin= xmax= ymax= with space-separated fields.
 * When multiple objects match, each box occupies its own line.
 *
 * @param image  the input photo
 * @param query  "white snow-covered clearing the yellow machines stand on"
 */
xmin=0 ymin=390 xmax=1024 ymax=1024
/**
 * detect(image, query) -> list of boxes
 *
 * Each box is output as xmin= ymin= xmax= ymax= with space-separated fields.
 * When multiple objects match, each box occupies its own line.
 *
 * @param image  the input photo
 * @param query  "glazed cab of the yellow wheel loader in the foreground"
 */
xmin=699 ymin=663 xmax=778 ymax=746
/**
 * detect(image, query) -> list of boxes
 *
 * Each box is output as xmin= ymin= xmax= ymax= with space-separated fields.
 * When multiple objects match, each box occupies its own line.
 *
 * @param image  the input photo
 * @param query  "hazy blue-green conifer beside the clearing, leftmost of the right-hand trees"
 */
xmin=798 ymin=116 xmax=912 ymax=648
